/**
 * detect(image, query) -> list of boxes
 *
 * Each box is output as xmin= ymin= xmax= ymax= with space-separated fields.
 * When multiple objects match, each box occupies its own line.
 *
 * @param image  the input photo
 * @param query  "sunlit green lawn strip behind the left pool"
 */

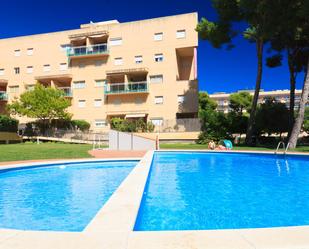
xmin=0 ymin=143 xmax=92 ymax=162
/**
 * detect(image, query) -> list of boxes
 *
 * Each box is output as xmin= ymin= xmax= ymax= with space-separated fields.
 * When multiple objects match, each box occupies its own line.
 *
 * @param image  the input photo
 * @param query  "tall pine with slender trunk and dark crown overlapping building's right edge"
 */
xmin=196 ymin=0 xmax=282 ymax=144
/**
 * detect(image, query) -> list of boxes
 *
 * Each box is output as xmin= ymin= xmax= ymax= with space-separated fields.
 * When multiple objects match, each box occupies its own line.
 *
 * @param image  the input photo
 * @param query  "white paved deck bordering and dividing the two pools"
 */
xmin=0 ymin=150 xmax=309 ymax=249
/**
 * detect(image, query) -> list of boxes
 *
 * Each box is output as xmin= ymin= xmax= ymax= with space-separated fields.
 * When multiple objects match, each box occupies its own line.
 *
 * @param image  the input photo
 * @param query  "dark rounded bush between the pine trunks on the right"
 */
xmin=256 ymin=98 xmax=289 ymax=136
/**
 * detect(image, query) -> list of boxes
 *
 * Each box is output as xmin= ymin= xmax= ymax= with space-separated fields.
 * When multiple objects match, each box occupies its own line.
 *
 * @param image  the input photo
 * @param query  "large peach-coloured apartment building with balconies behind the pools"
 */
xmin=0 ymin=13 xmax=198 ymax=130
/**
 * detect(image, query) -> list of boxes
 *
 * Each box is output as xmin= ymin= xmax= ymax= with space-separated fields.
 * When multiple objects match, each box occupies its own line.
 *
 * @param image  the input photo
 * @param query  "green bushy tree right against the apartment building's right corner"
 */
xmin=198 ymin=92 xmax=230 ymax=143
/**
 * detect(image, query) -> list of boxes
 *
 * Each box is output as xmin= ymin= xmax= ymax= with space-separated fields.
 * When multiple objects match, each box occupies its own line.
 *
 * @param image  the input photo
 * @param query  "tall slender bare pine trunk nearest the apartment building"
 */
xmin=245 ymin=40 xmax=264 ymax=145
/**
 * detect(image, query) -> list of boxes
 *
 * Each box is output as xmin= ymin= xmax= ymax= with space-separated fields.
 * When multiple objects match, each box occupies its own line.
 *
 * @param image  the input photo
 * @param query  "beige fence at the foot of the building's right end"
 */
xmin=154 ymin=118 xmax=201 ymax=132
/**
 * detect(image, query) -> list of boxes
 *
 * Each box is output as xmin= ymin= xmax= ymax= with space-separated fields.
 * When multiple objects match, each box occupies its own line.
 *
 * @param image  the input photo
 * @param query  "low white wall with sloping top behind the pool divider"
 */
xmin=109 ymin=130 xmax=156 ymax=150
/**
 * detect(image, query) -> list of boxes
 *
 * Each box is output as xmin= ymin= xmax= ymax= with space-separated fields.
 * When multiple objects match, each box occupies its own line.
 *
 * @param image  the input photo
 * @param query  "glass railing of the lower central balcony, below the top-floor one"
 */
xmin=104 ymin=81 xmax=148 ymax=94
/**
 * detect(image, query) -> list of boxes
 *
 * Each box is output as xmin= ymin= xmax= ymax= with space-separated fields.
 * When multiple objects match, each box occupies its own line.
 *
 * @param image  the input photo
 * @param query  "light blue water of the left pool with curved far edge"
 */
xmin=0 ymin=161 xmax=137 ymax=231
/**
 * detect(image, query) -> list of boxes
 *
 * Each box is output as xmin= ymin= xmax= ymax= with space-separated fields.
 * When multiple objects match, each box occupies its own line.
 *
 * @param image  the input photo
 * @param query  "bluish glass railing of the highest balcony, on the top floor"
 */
xmin=67 ymin=43 xmax=108 ymax=57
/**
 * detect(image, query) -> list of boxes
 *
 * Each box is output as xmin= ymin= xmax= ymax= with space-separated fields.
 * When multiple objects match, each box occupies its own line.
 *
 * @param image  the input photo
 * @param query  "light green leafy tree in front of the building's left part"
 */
xmin=8 ymin=84 xmax=71 ymax=132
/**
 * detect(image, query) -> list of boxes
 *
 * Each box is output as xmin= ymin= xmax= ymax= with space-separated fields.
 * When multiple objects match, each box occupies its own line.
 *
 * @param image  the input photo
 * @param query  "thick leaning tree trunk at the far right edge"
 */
xmin=289 ymin=58 xmax=309 ymax=149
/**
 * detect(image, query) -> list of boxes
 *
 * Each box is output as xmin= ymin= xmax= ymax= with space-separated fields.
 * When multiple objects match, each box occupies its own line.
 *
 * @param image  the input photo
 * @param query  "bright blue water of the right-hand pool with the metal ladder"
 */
xmin=134 ymin=152 xmax=309 ymax=231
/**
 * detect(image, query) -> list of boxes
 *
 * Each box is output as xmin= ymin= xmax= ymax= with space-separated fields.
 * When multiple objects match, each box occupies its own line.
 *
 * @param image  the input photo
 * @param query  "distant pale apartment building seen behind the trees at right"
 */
xmin=209 ymin=90 xmax=309 ymax=113
